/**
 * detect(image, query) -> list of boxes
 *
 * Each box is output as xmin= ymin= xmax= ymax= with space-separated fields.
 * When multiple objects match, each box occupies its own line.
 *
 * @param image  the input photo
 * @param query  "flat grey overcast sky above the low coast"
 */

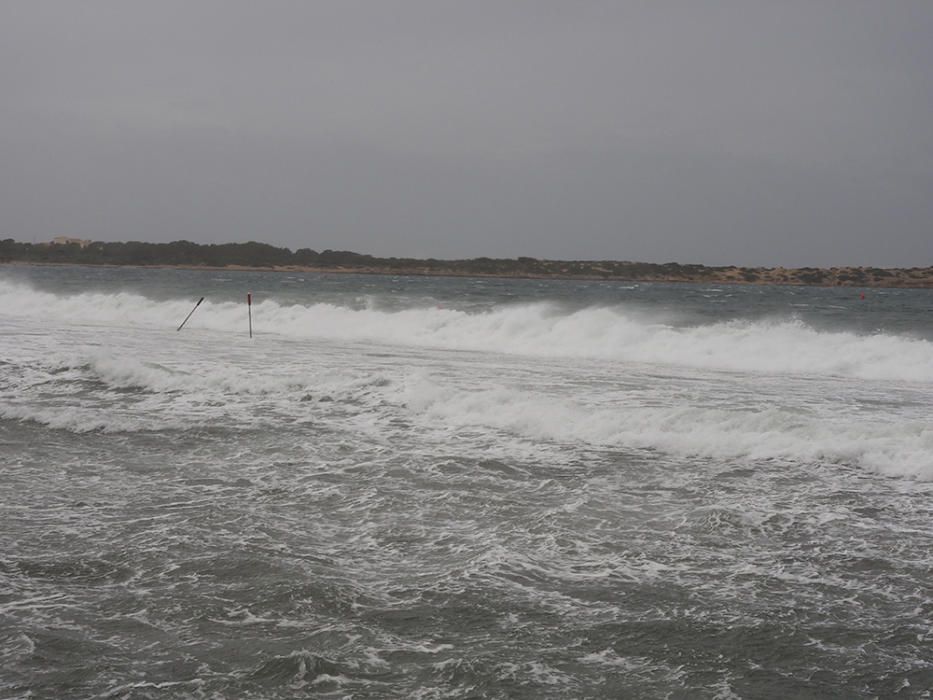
xmin=0 ymin=0 xmax=933 ymax=266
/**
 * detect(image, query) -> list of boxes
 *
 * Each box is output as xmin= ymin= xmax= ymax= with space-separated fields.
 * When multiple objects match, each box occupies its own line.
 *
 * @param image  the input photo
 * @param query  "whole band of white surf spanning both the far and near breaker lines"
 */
xmin=0 ymin=282 xmax=933 ymax=479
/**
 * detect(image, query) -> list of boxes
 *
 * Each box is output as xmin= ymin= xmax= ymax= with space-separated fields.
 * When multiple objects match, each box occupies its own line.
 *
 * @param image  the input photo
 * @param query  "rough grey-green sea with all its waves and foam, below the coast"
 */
xmin=0 ymin=265 xmax=933 ymax=700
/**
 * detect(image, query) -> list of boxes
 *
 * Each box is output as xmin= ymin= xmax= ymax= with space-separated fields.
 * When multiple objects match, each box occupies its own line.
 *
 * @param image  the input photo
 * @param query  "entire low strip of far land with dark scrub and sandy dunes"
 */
xmin=0 ymin=238 xmax=933 ymax=288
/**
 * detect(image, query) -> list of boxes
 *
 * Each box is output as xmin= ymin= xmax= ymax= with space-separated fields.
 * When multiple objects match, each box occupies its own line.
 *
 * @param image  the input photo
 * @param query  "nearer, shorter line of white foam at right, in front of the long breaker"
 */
xmin=405 ymin=380 xmax=933 ymax=479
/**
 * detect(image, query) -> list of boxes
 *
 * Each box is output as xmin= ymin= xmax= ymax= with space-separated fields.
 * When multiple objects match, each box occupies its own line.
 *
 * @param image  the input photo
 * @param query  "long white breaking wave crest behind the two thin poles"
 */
xmin=0 ymin=282 xmax=933 ymax=383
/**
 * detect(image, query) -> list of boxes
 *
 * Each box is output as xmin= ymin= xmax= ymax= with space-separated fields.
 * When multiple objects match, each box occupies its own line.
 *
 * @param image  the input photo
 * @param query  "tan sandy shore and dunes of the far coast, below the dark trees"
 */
xmin=0 ymin=260 xmax=933 ymax=289
